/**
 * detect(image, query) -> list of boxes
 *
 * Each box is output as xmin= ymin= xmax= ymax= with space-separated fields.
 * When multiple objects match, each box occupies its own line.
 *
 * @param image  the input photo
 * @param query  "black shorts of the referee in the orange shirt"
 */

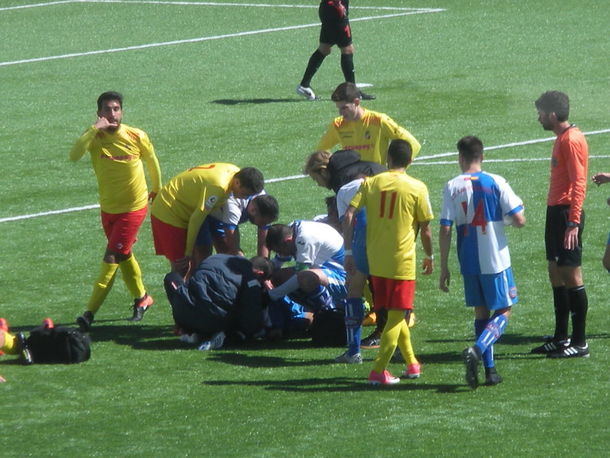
xmin=544 ymin=205 xmax=585 ymax=267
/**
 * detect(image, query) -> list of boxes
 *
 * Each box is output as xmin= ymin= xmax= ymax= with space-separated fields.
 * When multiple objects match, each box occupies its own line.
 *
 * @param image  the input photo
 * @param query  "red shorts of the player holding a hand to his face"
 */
xmin=102 ymin=207 xmax=148 ymax=255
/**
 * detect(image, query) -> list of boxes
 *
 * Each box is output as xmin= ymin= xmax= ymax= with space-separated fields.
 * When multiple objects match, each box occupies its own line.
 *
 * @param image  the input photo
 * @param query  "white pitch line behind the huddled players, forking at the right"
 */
xmin=0 ymin=129 xmax=610 ymax=223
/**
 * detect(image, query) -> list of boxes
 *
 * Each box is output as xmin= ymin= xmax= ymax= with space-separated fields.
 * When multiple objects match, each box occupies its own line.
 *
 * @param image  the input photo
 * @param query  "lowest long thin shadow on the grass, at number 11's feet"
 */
xmin=202 ymin=377 xmax=464 ymax=394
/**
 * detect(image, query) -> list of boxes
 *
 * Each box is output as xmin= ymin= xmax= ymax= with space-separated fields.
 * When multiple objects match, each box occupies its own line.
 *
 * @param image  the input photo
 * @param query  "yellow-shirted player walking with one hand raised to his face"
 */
xmin=70 ymin=92 xmax=161 ymax=331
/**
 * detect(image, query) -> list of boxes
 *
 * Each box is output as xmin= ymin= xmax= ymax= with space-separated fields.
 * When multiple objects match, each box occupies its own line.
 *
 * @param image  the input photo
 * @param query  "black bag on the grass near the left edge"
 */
xmin=27 ymin=326 xmax=91 ymax=364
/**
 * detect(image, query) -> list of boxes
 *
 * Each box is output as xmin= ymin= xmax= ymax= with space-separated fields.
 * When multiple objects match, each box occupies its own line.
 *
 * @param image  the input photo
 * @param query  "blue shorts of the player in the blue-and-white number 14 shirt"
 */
xmin=464 ymin=267 xmax=519 ymax=310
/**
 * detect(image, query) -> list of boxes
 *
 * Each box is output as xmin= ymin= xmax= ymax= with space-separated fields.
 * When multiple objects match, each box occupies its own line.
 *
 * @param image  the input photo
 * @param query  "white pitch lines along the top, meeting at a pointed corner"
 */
xmin=0 ymin=0 xmax=445 ymax=67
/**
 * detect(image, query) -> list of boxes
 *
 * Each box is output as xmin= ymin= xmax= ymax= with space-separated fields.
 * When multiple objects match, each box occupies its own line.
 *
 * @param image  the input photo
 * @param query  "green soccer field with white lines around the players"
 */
xmin=0 ymin=0 xmax=610 ymax=456
